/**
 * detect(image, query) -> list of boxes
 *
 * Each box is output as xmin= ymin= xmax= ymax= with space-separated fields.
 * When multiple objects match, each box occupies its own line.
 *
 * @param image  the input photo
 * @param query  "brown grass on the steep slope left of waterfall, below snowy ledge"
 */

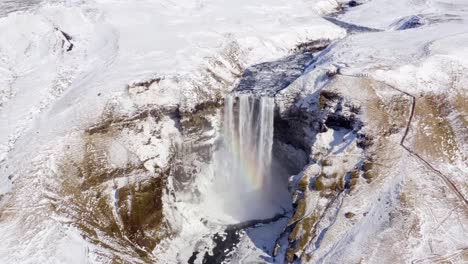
xmin=51 ymin=112 xmax=173 ymax=263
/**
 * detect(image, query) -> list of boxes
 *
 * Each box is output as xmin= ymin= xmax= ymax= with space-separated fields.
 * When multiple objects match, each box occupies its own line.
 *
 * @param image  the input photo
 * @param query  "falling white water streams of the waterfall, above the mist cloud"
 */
xmin=218 ymin=94 xmax=275 ymax=191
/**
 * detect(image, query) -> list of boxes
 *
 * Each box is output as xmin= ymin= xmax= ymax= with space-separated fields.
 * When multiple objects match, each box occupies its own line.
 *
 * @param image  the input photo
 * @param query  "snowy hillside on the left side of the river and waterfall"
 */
xmin=0 ymin=0 xmax=344 ymax=263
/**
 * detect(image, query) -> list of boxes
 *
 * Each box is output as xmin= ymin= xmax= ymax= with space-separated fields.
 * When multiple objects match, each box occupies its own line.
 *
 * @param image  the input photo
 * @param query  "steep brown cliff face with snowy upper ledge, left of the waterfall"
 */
xmin=53 ymin=105 xmax=179 ymax=262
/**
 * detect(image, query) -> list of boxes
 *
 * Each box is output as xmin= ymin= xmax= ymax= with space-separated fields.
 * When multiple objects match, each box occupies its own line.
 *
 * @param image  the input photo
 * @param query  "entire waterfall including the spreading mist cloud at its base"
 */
xmin=210 ymin=93 xmax=289 ymax=220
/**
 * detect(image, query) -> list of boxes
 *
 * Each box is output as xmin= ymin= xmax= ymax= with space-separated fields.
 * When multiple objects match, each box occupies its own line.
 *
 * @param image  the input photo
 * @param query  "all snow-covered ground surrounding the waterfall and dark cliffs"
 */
xmin=0 ymin=0 xmax=468 ymax=263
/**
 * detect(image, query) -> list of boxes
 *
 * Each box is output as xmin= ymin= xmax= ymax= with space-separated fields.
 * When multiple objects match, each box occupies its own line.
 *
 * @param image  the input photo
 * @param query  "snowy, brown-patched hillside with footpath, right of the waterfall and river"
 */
xmin=270 ymin=0 xmax=468 ymax=263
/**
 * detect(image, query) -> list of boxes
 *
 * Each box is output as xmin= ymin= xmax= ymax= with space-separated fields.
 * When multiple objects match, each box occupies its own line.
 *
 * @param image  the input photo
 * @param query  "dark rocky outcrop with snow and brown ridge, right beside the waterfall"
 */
xmin=275 ymin=77 xmax=372 ymax=263
